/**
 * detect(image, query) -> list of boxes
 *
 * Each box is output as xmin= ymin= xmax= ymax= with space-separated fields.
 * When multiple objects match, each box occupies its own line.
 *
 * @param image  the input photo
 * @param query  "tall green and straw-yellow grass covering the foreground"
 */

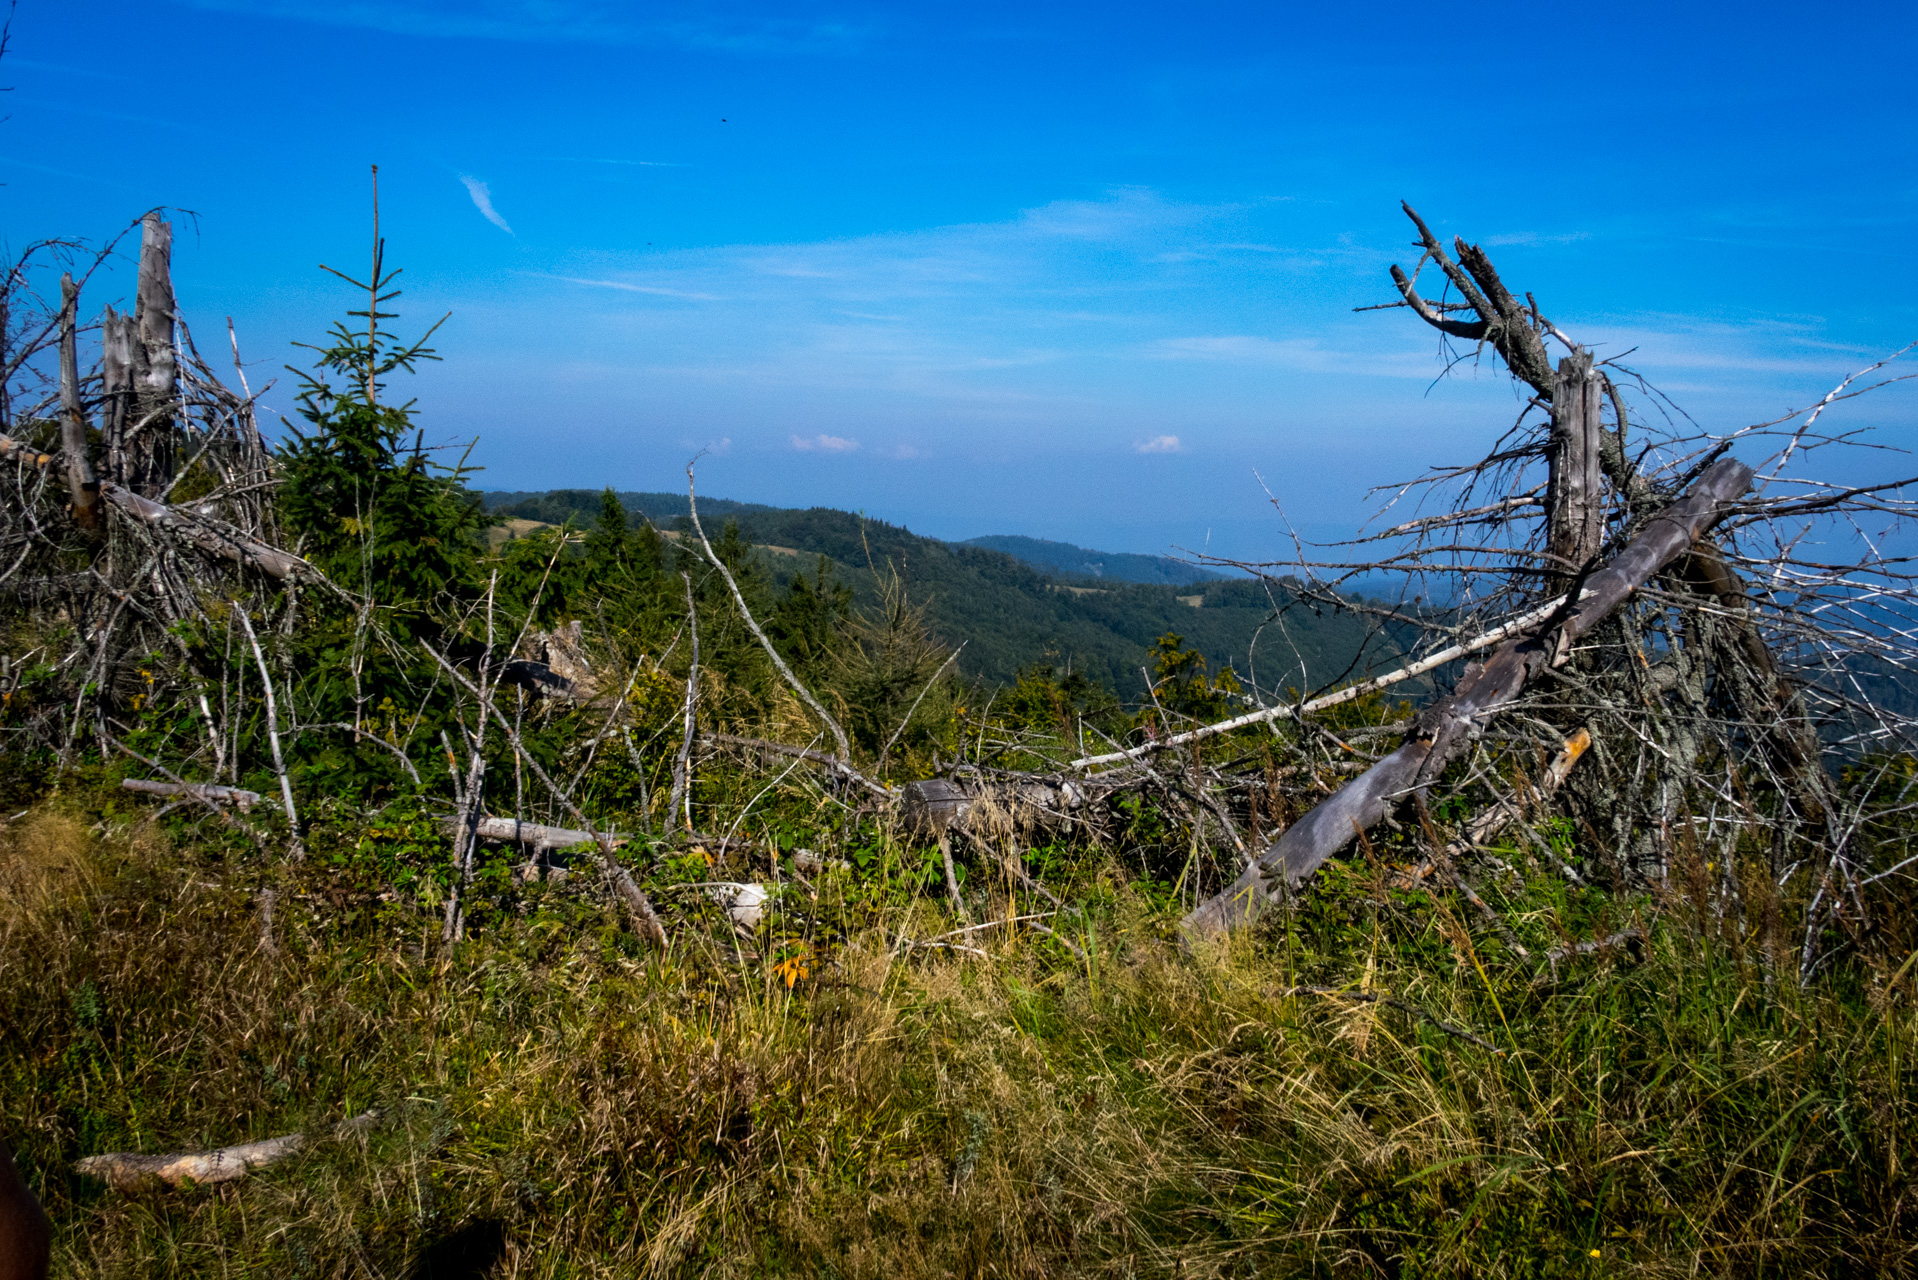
xmin=0 ymin=798 xmax=1918 ymax=1280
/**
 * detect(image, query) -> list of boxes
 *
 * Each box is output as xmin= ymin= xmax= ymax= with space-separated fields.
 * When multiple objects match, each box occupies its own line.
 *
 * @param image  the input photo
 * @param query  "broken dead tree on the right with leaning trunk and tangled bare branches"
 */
xmin=1187 ymin=207 xmax=1918 ymax=975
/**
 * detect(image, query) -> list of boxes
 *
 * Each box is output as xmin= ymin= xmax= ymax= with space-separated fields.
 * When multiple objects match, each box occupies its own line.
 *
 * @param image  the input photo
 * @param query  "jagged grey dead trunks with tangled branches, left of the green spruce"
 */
xmin=0 ymin=213 xmax=320 ymax=836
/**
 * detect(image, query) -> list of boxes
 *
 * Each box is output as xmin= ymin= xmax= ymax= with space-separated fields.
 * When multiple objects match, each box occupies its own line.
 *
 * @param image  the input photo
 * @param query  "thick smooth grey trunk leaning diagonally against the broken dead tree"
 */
xmin=1183 ymin=457 xmax=1753 ymax=935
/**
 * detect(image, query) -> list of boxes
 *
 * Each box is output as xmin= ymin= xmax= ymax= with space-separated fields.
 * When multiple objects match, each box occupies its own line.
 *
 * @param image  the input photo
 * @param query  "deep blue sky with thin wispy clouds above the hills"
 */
xmin=0 ymin=0 xmax=1918 ymax=557
